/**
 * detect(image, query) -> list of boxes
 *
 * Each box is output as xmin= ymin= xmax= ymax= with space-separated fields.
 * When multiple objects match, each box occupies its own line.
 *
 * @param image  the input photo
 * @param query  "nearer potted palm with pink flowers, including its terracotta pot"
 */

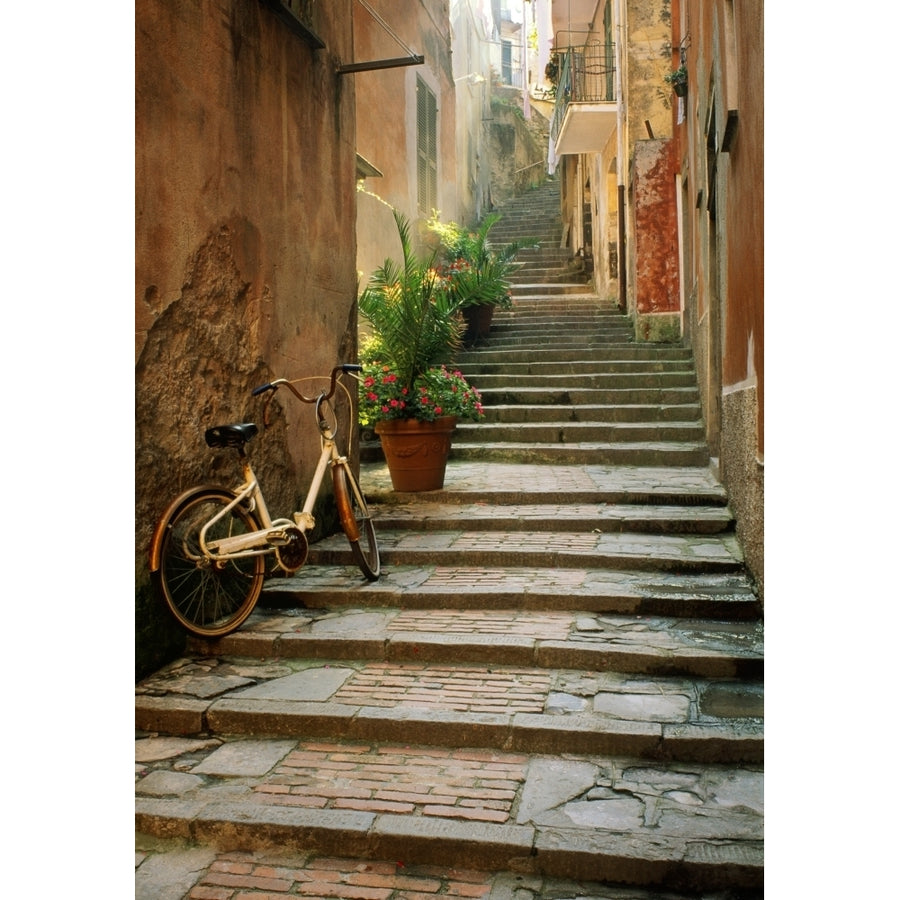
xmin=359 ymin=211 xmax=484 ymax=491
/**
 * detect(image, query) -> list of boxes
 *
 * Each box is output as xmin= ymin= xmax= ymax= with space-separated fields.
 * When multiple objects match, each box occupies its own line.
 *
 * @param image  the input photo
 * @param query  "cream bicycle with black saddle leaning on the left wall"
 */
xmin=150 ymin=363 xmax=381 ymax=638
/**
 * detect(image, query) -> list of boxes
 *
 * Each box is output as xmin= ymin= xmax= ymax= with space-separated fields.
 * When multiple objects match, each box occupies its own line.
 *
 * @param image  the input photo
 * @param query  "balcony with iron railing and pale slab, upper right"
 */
xmin=550 ymin=44 xmax=616 ymax=156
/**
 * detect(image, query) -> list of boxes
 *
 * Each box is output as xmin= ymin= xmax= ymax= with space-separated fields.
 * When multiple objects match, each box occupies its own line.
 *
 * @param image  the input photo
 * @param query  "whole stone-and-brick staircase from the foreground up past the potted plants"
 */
xmin=135 ymin=179 xmax=763 ymax=900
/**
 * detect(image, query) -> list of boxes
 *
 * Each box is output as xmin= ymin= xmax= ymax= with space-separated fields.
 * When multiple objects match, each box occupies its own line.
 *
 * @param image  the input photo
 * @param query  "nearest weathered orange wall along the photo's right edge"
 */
xmin=673 ymin=0 xmax=765 ymax=590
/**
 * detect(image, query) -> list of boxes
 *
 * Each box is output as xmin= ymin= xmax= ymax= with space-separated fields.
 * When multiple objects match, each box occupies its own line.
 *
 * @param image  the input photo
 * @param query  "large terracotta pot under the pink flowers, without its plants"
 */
xmin=375 ymin=416 xmax=456 ymax=491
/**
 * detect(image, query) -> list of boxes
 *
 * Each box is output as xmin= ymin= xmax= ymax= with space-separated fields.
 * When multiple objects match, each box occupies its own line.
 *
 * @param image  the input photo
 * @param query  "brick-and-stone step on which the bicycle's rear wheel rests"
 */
xmin=179 ymin=606 xmax=763 ymax=676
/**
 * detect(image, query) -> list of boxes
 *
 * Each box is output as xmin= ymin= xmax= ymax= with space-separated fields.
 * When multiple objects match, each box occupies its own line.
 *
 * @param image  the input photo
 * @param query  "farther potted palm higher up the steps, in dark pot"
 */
xmin=428 ymin=213 xmax=537 ymax=346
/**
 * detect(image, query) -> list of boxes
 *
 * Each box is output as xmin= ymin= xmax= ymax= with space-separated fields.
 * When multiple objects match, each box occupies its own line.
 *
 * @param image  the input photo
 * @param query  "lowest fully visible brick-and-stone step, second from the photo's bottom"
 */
xmin=135 ymin=738 xmax=763 ymax=895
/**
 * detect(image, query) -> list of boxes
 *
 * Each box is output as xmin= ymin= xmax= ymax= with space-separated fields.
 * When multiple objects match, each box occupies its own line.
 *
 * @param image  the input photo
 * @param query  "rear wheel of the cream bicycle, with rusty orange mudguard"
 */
xmin=152 ymin=488 xmax=265 ymax=638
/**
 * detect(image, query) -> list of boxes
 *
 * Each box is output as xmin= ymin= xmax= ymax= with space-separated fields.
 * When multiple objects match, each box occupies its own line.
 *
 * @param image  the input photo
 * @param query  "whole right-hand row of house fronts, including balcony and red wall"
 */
xmin=550 ymin=0 xmax=764 ymax=593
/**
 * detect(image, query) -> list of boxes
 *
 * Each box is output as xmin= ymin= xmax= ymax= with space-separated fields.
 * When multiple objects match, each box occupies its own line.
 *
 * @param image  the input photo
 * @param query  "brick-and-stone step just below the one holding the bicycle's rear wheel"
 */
xmin=135 ymin=656 xmax=763 ymax=762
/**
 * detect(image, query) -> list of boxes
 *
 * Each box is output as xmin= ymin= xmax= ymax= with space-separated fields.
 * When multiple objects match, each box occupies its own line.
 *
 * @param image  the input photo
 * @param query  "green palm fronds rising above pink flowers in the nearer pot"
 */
xmin=359 ymin=210 xmax=465 ymax=392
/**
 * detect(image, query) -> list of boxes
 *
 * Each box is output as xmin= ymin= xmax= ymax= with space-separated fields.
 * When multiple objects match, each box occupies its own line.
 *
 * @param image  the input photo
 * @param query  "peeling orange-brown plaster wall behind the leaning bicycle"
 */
xmin=135 ymin=0 xmax=356 ymax=673
